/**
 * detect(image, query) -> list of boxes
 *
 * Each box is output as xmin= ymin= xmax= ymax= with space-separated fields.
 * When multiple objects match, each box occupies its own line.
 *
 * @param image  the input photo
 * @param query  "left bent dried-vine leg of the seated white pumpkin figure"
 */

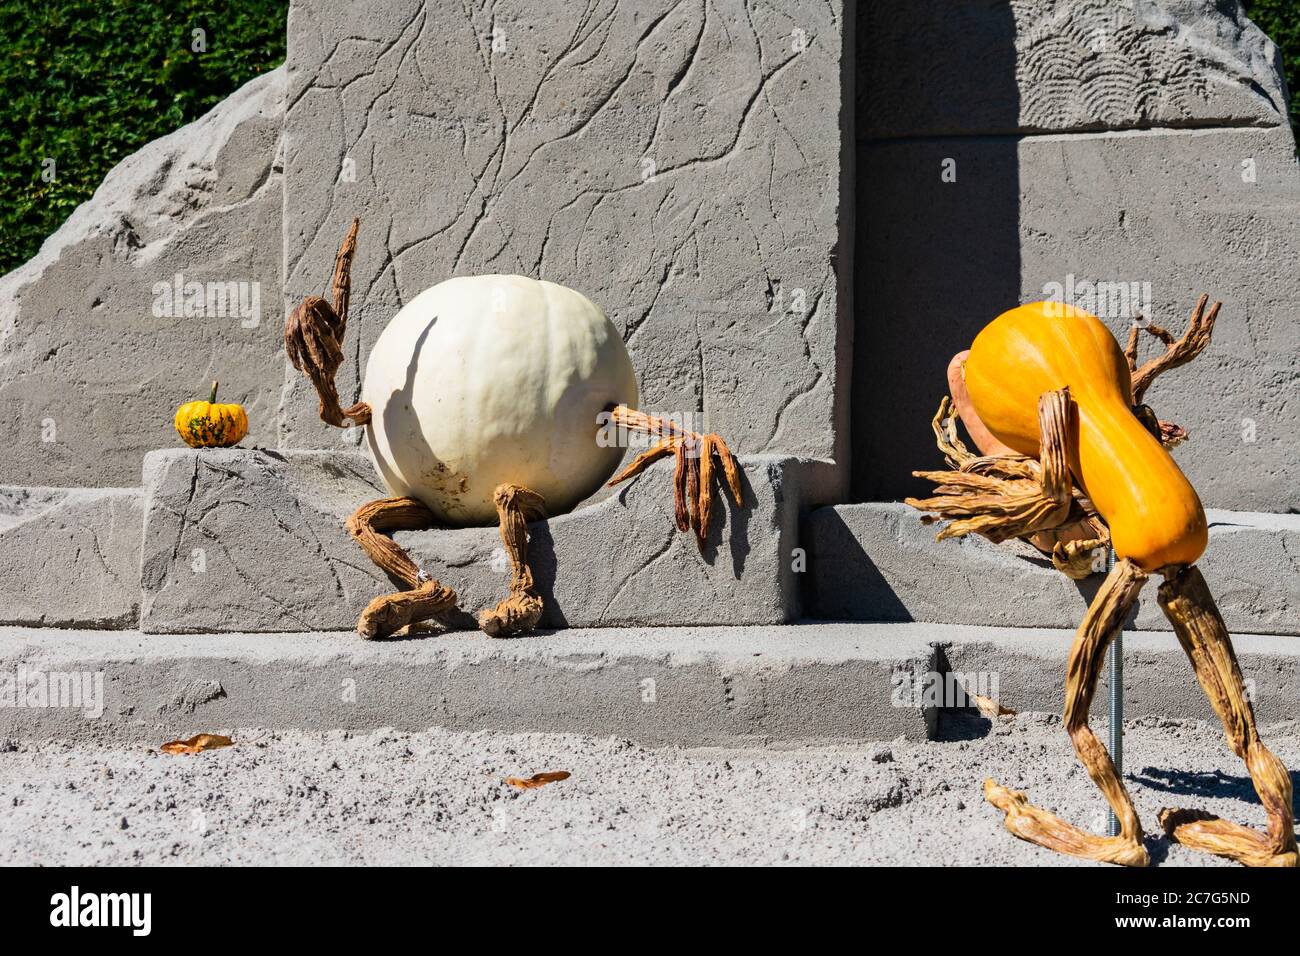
xmin=347 ymin=498 xmax=456 ymax=639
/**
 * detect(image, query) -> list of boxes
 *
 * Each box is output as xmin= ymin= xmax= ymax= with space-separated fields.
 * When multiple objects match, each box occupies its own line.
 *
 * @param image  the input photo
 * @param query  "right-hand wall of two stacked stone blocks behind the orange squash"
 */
xmin=853 ymin=0 xmax=1300 ymax=512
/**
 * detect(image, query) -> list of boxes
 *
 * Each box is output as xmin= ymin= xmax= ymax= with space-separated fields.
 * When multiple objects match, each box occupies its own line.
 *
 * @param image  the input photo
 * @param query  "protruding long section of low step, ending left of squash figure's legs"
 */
xmin=0 ymin=626 xmax=935 ymax=745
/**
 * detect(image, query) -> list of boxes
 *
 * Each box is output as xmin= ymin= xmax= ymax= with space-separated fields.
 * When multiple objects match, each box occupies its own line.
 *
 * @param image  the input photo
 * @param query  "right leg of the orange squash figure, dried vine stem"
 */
xmin=1160 ymin=566 xmax=1297 ymax=866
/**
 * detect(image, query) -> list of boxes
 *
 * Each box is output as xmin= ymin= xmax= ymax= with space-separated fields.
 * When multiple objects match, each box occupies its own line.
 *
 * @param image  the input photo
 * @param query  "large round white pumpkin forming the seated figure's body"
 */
xmin=361 ymin=276 xmax=637 ymax=525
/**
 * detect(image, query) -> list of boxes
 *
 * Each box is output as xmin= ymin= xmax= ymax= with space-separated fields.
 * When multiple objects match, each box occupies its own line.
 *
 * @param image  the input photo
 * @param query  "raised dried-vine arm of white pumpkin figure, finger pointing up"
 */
xmin=285 ymin=219 xmax=371 ymax=428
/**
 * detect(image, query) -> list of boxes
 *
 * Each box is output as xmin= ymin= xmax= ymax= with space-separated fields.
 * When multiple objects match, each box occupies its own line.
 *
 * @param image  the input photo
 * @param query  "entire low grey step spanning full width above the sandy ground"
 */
xmin=0 ymin=623 xmax=1300 ymax=747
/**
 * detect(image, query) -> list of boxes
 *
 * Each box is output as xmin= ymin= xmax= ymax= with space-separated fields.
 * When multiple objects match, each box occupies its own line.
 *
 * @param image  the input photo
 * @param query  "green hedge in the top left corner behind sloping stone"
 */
xmin=0 ymin=0 xmax=289 ymax=274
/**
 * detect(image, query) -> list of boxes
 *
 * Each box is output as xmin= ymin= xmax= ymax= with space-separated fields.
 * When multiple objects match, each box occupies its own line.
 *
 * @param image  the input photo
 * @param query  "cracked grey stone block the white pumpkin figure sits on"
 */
xmin=140 ymin=449 xmax=818 ymax=633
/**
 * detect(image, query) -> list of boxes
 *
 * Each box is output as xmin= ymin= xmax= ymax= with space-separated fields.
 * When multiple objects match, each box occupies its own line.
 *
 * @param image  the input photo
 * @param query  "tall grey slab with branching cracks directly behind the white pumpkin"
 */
xmin=280 ymin=0 xmax=846 ymax=458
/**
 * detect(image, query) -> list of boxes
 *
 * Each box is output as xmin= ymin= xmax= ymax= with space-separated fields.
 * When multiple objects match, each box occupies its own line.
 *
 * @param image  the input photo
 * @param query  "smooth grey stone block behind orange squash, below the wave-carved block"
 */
xmin=854 ymin=127 xmax=1300 ymax=512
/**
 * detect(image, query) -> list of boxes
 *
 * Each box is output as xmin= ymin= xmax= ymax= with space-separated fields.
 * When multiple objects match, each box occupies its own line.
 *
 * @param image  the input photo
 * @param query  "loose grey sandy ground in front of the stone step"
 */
xmin=0 ymin=714 xmax=1300 ymax=866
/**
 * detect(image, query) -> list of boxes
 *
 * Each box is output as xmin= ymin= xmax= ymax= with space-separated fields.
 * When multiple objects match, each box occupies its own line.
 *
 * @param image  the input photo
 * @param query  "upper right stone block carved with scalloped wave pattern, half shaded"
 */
xmin=858 ymin=0 xmax=1287 ymax=139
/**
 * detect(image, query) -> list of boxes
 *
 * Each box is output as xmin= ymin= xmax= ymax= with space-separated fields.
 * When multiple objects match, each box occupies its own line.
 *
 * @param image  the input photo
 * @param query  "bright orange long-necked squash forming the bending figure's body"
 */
xmin=965 ymin=302 xmax=1208 ymax=572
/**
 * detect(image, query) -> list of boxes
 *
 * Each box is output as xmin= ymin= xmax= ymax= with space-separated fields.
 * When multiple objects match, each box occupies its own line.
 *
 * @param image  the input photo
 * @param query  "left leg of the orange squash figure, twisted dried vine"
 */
xmin=984 ymin=561 xmax=1149 ymax=866
